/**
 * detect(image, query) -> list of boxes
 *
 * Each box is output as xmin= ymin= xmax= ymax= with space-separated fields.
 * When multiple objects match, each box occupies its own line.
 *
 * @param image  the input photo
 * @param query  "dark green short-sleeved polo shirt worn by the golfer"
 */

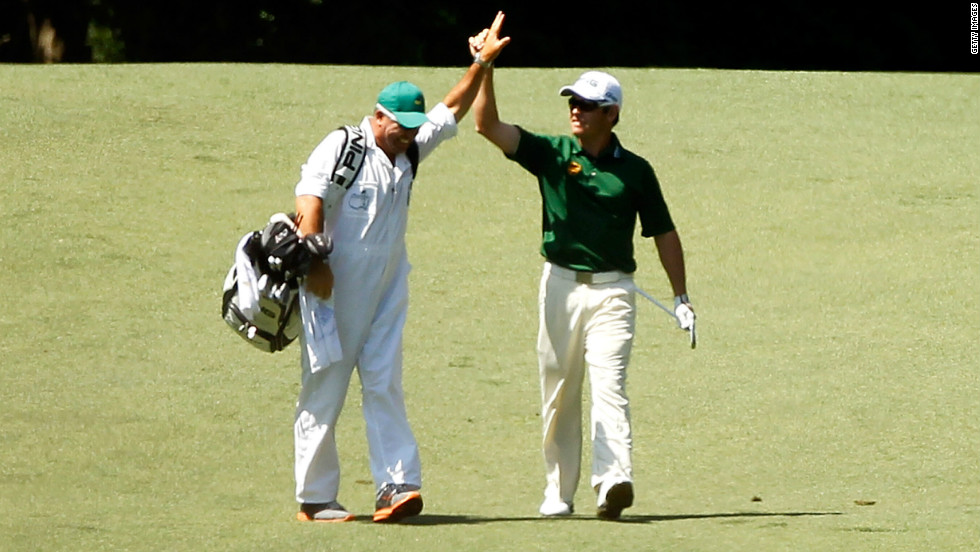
xmin=509 ymin=129 xmax=674 ymax=273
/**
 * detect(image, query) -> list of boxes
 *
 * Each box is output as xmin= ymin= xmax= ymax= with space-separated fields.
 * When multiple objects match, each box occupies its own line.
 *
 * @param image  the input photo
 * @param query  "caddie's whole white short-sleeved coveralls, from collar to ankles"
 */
xmin=294 ymin=103 xmax=457 ymax=503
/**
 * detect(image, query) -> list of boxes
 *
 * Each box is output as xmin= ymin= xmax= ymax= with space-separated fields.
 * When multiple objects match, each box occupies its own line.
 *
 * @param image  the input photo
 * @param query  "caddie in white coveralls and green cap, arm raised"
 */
xmin=294 ymin=14 xmax=509 ymax=522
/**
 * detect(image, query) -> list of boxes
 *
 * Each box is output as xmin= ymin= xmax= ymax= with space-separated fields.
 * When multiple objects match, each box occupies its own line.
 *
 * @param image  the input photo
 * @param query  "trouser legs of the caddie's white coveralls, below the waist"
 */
xmin=294 ymin=254 xmax=422 ymax=503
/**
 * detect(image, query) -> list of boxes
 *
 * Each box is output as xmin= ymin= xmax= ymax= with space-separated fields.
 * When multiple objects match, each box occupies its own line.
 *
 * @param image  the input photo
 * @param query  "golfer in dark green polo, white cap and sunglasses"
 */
xmin=473 ymin=70 xmax=694 ymax=519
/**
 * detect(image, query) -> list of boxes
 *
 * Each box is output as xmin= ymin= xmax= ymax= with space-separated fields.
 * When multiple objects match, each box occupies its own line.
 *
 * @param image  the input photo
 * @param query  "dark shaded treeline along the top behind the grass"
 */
xmin=0 ymin=0 xmax=980 ymax=72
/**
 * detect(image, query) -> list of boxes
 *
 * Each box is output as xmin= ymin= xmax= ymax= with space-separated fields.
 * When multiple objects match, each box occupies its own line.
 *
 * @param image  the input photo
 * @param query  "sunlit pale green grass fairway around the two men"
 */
xmin=0 ymin=65 xmax=980 ymax=551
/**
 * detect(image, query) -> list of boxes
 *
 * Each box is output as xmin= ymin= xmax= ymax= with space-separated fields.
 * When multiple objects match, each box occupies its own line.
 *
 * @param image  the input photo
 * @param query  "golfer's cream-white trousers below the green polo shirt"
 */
xmin=538 ymin=263 xmax=636 ymax=504
